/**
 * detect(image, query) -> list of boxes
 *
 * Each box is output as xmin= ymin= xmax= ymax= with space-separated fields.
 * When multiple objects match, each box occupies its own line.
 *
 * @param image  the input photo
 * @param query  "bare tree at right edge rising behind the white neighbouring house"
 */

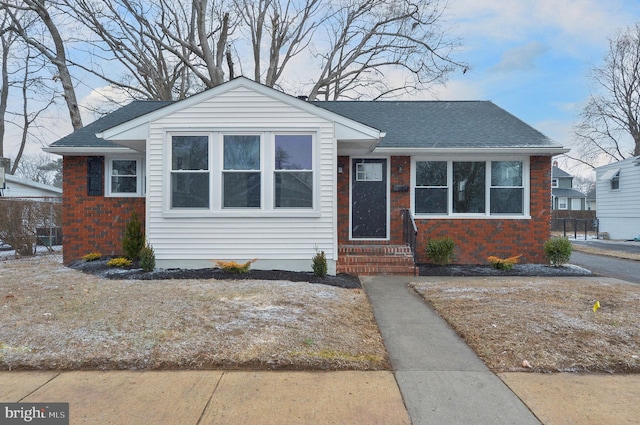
xmin=575 ymin=23 xmax=640 ymax=166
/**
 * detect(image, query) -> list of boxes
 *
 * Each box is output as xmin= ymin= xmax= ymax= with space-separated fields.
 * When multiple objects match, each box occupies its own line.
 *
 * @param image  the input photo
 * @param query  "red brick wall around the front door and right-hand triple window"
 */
xmin=338 ymin=156 xmax=551 ymax=264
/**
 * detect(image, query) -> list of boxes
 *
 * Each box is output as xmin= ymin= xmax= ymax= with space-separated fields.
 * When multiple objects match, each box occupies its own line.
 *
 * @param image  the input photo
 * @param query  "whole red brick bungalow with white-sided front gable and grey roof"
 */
xmin=45 ymin=77 xmax=566 ymax=274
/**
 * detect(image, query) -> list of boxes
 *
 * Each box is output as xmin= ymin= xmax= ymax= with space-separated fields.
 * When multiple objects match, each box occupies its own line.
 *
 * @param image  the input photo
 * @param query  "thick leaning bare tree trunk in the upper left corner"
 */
xmin=0 ymin=0 xmax=82 ymax=130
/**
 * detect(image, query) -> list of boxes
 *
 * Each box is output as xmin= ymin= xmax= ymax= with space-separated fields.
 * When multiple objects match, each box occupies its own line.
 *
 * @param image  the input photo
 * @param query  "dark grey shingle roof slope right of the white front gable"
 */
xmin=314 ymin=101 xmax=561 ymax=148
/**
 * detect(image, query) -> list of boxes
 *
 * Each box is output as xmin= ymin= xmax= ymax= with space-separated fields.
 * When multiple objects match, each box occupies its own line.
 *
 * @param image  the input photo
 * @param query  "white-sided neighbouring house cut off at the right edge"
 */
xmin=596 ymin=156 xmax=640 ymax=239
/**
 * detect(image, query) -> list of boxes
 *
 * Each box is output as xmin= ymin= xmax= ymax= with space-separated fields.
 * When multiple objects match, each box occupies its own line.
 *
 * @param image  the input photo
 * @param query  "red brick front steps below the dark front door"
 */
xmin=336 ymin=245 xmax=415 ymax=276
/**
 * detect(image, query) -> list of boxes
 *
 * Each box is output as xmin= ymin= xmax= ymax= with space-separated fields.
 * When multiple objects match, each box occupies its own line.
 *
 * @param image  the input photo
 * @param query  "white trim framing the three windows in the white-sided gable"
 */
xmin=162 ymin=128 xmax=321 ymax=218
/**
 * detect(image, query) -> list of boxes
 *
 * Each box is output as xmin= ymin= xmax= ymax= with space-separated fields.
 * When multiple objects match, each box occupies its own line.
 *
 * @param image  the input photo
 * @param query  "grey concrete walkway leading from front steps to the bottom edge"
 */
xmin=361 ymin=276 xmax=540 ymax=425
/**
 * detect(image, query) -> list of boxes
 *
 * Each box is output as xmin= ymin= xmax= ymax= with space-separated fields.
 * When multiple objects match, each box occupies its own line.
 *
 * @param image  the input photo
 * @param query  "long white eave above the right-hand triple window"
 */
xmin=373 ymin=147 xmax=570 ymax=156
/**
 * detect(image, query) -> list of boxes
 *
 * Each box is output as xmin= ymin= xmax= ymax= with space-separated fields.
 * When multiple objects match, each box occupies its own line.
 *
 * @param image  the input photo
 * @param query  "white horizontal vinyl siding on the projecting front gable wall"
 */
xmin=147 ymin=87 xmax=337 ymax=270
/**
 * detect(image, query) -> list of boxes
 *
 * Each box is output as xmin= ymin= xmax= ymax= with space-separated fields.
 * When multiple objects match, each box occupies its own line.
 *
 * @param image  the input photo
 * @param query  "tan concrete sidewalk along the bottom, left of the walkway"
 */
xmin=0 ymin=371 xmax=410 ymax=425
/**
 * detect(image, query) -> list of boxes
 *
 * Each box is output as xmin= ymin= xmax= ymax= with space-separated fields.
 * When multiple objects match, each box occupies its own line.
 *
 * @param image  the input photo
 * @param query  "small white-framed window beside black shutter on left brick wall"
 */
xmin=105 ymin=158 xmax=144 ymax=197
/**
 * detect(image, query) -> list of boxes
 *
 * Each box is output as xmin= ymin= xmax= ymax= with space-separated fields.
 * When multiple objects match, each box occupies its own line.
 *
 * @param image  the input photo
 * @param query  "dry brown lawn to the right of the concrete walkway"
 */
xmin=411 ymin=277 xmax=640 ymax=373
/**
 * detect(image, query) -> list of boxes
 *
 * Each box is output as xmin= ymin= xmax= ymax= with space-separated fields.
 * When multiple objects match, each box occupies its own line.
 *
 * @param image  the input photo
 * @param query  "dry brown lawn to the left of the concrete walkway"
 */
xmin=0 ymin=255 xmax=389 ymax=370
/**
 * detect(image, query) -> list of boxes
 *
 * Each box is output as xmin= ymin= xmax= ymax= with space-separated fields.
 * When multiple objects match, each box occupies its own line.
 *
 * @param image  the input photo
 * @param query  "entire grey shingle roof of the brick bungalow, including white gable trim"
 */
xmin=44 ymin=77 xmax=568 ymax=155
